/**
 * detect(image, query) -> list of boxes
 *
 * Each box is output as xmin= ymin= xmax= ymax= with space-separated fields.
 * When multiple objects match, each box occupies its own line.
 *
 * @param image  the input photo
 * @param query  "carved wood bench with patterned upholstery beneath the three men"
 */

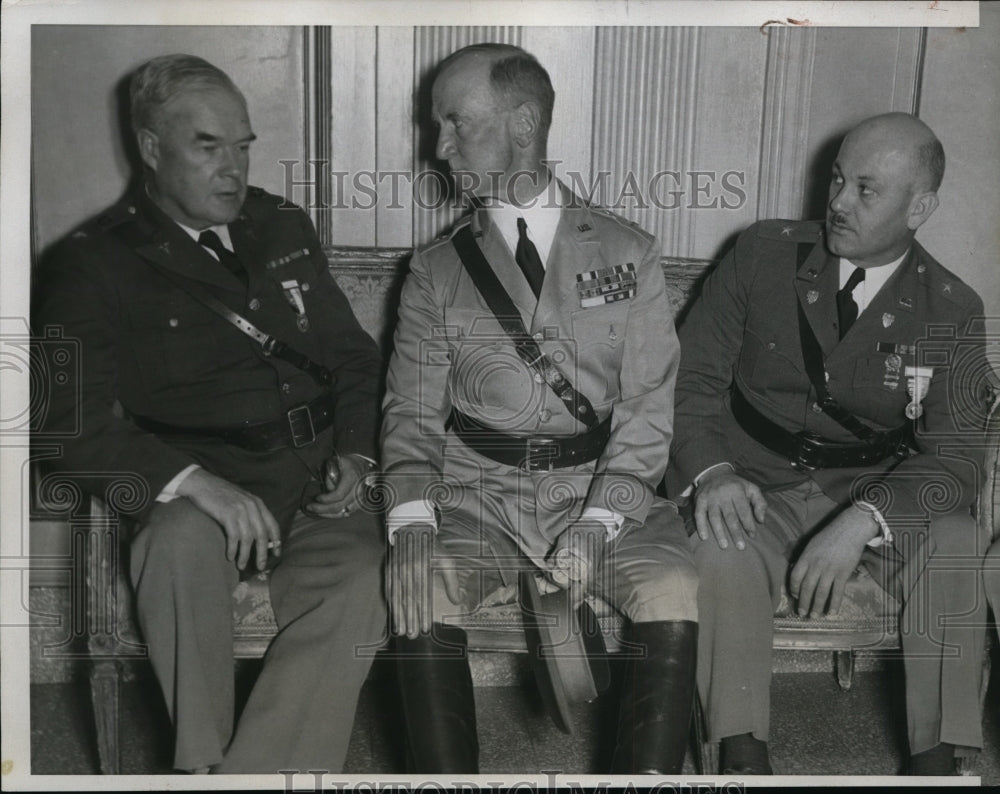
xmin=35 ymin=248 xmax=1000 ymax=774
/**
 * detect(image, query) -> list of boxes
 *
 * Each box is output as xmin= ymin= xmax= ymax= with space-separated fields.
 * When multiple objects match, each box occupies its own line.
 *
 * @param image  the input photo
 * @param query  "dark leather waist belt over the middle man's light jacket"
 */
xmin=449 ymin=410 xmax=611 ymax=471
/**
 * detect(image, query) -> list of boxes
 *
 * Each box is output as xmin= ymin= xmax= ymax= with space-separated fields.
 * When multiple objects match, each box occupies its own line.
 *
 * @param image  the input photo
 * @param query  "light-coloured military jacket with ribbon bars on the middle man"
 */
xmin=382 ymin=185 xmax=679 ymax=522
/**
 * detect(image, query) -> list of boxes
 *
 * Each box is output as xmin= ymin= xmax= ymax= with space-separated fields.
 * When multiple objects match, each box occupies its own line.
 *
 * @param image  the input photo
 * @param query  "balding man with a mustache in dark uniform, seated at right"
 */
xmin=667 ymin=113 xmax=988 ymax=774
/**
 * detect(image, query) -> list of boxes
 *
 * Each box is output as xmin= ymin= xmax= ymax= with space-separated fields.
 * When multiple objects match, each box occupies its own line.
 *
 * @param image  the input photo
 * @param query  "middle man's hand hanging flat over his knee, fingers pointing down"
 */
xmin=386 ymin=523 xmax=463 ymax=639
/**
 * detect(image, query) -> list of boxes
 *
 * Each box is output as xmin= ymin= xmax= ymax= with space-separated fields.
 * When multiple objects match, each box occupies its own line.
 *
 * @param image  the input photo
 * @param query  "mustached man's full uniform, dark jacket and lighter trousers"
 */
xmin=667 ymin=221 xmax=985 ymax=753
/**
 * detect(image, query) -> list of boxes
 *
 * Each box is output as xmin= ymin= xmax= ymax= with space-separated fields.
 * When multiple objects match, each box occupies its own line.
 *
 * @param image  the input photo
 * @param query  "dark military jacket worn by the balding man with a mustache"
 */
xmin=667 ymin=221 xmax=988 ymax=517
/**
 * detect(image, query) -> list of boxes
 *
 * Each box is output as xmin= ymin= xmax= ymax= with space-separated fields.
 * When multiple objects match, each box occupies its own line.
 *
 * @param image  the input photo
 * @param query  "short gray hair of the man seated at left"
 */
xmin=129 ymin=53 xmax=247 ymax=132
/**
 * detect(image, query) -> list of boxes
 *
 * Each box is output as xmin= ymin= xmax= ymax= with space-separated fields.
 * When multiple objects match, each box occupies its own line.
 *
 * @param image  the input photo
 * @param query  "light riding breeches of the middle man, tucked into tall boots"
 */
xmin=422 ymin=447 xmax=698 ymax=623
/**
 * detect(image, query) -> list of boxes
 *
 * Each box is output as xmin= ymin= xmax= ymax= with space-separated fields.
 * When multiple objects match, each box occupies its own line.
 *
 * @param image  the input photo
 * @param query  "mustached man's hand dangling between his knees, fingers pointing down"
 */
xmin=788 ymin=506 xmax=880 ymax=618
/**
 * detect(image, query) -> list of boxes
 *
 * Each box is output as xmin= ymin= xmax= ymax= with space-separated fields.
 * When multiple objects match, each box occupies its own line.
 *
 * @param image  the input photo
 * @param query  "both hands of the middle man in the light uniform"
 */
xmin=386 ymin=520 xmax=607 ymax=639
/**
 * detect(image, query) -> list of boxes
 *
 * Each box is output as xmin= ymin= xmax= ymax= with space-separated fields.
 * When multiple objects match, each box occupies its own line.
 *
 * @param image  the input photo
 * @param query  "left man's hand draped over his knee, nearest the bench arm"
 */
xmin=177 ymin=469 xmax=281 ymax=571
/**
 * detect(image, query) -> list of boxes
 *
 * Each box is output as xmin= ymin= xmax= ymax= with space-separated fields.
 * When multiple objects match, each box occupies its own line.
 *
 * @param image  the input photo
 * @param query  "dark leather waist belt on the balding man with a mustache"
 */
xmin=732 ymin=388 xmax=910 ymax=470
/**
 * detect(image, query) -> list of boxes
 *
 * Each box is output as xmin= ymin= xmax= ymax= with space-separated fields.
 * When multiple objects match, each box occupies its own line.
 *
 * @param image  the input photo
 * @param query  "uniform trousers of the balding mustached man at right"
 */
xmin=691 ymin=480 xmax=986 ymax=753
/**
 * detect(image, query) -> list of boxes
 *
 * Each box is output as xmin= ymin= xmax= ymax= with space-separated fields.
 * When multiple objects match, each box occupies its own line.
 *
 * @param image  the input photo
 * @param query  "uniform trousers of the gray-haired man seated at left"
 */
xmin=131 ymin=499 xmax=385 ymax=774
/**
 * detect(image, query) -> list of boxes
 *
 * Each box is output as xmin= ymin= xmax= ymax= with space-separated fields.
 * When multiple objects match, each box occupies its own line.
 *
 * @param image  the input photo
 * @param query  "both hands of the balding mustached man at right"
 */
xmin=694 ymin=469 xmax=878 ymax=618
